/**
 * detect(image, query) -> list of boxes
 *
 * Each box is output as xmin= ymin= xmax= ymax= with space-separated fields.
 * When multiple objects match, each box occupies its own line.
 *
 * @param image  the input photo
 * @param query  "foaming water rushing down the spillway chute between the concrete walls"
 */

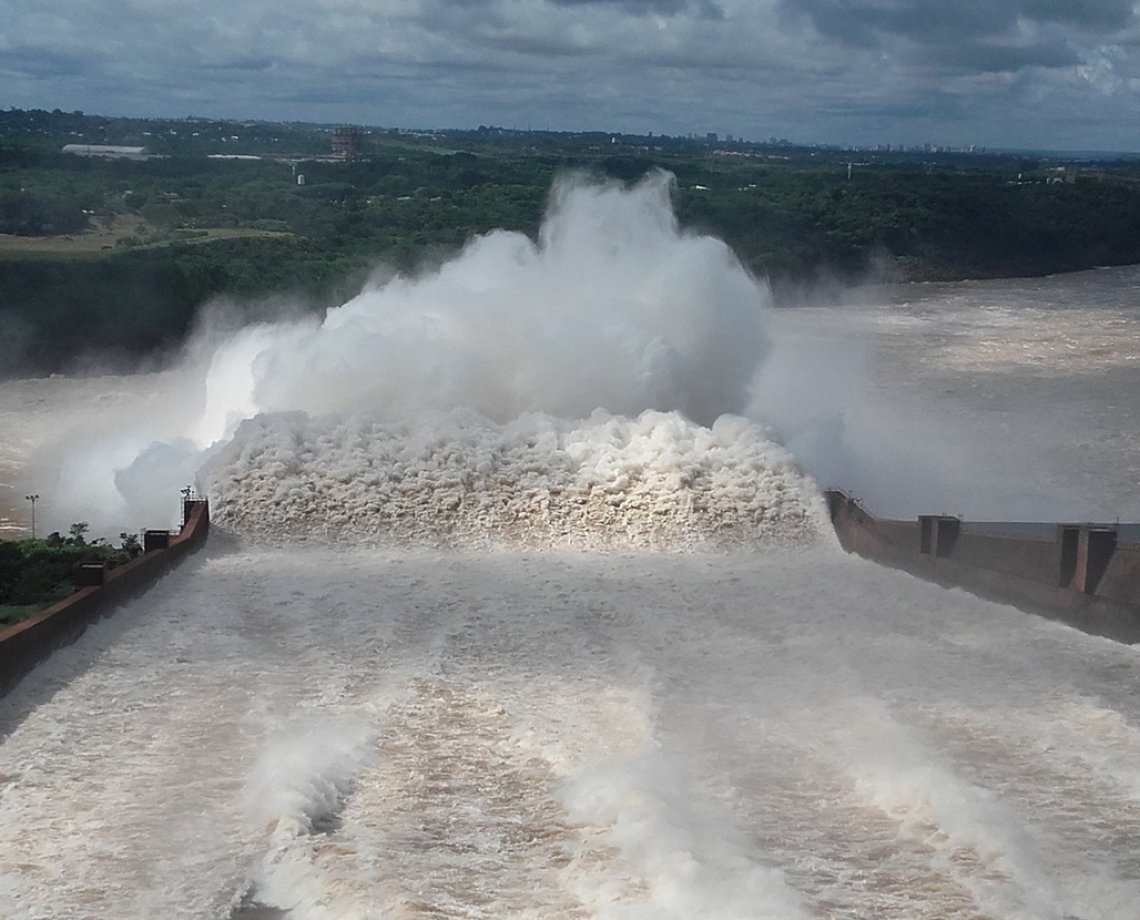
xmin=0 ymin=543 xmax=1140 ymax=920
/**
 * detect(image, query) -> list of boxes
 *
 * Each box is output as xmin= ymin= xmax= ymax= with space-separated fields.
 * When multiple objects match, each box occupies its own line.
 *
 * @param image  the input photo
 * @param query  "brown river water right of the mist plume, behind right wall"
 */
xmin=756 ymin=267 xmax=1140 ymax=521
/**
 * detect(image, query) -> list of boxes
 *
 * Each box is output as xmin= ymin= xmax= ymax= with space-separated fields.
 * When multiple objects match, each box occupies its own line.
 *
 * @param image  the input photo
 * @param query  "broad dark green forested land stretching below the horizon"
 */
xmin=0 ymin=111 xmax=1140 ymax=374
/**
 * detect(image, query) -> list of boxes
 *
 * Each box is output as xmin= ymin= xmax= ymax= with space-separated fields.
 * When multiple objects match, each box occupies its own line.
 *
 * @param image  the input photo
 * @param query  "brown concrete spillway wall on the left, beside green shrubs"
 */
xmin=0 ymin=499 xmax=210 ymax=695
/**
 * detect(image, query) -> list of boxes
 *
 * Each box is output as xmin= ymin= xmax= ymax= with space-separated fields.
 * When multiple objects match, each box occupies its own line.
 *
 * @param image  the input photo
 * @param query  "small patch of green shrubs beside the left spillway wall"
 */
xmin=0 ymin=522 xmax=143 ymax=629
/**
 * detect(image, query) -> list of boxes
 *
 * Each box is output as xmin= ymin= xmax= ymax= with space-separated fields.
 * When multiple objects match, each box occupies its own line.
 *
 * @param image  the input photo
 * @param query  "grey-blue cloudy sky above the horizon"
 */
xmin=0 ymin=0 xmax=1140 ymax=150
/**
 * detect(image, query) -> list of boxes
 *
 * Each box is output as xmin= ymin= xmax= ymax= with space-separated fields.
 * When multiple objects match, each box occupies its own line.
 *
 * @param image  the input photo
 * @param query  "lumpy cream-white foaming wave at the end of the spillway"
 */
xmin=203 ymin=410 xmax=821 ymax=549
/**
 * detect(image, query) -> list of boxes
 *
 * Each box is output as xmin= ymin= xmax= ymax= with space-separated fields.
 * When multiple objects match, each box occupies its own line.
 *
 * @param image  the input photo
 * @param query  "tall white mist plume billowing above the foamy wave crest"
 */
xmin=37 ymin=171 xmax=784 ymax=526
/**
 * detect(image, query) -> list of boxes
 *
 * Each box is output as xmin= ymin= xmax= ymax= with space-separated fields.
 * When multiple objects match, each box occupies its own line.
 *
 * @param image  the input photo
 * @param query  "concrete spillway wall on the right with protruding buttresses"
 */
xmin=827 ymin=490 xmax=1140 ymax=643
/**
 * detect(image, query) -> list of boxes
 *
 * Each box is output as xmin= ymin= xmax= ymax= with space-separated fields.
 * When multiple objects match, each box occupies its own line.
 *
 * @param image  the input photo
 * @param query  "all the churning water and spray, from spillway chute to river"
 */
xmin=0 ymin=177 xmax=1140 ymax=920
